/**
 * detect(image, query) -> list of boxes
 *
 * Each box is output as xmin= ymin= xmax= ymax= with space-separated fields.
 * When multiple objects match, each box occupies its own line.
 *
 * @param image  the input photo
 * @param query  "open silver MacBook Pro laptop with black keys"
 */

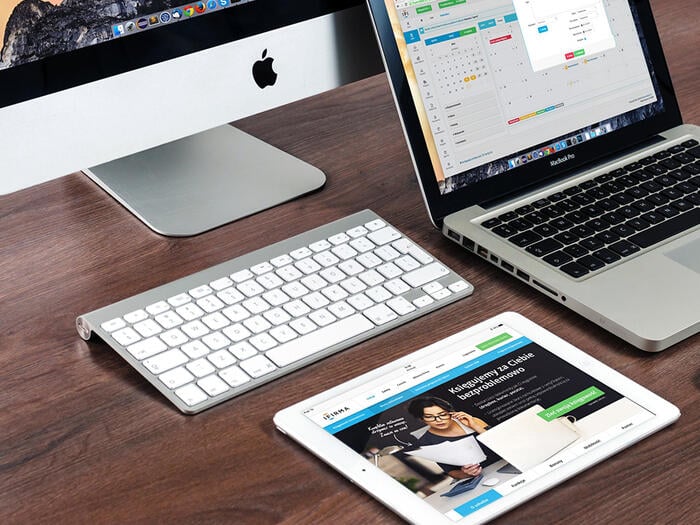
xmin=369 ymin=0 xmax=700 ymax=351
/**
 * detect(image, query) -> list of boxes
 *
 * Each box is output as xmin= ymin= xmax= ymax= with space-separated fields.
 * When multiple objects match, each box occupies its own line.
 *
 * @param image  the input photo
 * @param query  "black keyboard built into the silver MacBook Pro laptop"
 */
xmin=481 ymin=139 xmax=700 ymax=278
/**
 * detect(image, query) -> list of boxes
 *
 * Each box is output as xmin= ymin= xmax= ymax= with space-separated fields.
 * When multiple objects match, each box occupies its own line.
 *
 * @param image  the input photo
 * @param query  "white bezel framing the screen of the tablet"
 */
xmin=274 ymin=312 xmax=680 ymax=525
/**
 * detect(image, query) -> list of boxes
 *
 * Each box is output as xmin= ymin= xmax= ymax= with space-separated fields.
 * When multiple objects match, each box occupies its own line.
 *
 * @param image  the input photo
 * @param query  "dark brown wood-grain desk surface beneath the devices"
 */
xmin=0 ymin=0 xmax=700 ymax=525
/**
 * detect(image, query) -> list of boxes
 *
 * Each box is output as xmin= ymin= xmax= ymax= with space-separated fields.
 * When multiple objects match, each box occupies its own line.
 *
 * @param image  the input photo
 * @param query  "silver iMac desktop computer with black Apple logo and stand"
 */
xmin=0 ymin=0 xmax=383 ymax=236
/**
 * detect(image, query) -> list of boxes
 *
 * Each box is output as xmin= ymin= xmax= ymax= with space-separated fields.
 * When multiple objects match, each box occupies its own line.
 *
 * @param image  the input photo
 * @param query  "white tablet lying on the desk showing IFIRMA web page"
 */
xmin=274 ymin=312 xmax=680 ymax=525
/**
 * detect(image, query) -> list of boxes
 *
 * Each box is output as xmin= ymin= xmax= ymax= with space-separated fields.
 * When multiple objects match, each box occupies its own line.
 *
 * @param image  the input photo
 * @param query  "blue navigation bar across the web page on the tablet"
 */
xmin=324 ymin=337 xmax=532 ymax=434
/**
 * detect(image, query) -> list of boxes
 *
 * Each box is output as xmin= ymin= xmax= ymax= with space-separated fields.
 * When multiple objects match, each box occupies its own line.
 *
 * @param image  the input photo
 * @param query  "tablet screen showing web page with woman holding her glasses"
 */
xmin=305 ymin=323 xmax=654 ymax=521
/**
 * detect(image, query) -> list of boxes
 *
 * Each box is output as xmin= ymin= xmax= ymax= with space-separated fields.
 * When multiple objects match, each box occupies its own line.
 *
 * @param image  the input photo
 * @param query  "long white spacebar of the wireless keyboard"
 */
xmin=265 ymin=314 xmax=374 ymax=366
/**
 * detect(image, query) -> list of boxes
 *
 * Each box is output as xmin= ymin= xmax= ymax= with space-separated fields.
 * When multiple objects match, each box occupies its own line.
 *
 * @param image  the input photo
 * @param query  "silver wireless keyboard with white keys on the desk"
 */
xmin=76 ymin=210 xmax=473 ymax=414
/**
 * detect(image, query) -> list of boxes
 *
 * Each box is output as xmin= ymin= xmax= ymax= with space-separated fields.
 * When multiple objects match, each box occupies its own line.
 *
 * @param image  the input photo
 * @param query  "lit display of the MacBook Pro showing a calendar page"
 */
xmin=371 ymin=0 xmax=675 ymax=215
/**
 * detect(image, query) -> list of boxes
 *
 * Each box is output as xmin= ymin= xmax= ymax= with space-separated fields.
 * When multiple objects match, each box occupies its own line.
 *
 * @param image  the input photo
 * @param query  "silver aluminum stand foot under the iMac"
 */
xmin=84 ymin=125 xmax=326 ymax=237
